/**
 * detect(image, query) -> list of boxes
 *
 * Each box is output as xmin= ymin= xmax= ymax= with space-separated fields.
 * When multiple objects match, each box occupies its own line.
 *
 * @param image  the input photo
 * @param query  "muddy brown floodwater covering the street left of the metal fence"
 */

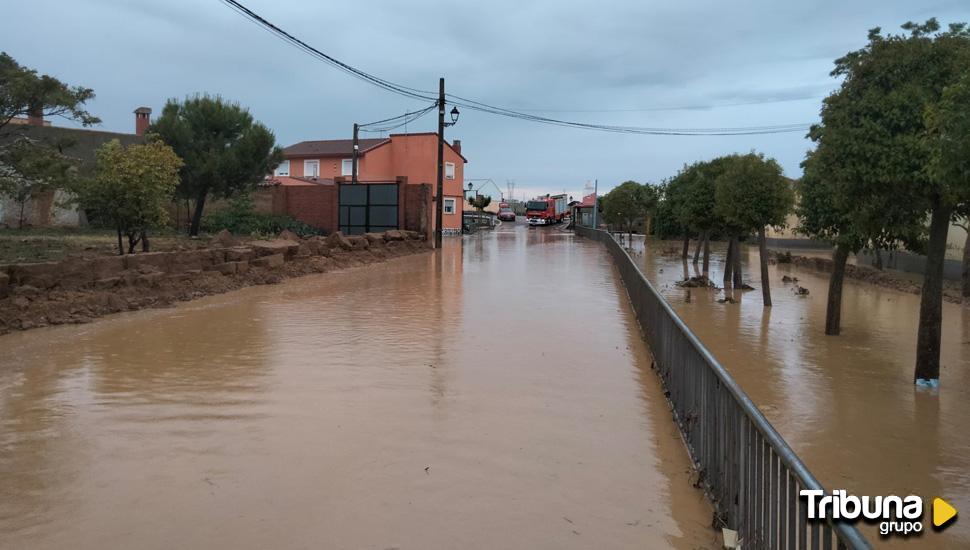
xmin=0 ymin=225 xmax=716 ymax=549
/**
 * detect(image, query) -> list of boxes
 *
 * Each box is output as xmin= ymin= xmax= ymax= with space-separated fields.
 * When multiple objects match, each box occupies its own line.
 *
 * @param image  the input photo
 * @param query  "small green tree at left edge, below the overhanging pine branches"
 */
xmin=0 ymin=137 xmax=78 ymax=229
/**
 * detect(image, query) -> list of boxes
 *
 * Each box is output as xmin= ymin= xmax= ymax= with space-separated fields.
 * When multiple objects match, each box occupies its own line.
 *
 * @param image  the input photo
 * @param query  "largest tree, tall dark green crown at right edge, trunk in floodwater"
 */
xmin=820 ymin=19 xmax=970 ymax=381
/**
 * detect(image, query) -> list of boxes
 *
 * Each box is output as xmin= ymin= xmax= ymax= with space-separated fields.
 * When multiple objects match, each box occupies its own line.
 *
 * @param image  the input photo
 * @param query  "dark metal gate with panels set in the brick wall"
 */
xmin=338 ymin=183 xmax=399 ymax=235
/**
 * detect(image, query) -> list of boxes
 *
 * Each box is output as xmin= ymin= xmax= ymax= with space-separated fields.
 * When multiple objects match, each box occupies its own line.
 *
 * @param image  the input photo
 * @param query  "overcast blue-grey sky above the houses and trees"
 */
xmin=0 ymin=0 xmax=970 ymax=203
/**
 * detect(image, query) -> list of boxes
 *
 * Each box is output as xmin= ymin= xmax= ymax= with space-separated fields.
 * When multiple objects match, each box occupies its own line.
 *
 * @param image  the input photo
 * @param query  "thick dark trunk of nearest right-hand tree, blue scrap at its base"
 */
xmin=913 ymin=206 xmax=952 ymax=380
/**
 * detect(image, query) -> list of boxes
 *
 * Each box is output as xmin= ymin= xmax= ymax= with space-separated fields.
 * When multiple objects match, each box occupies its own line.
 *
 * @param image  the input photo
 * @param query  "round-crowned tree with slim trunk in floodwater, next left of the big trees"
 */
xmin=714 ymin=153 xmax=794 ymax=307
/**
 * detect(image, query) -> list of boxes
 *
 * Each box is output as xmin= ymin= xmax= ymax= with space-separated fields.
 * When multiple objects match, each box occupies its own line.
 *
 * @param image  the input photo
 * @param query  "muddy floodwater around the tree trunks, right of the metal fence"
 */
xmin=633 ymin=237 xmax=970 ymax=548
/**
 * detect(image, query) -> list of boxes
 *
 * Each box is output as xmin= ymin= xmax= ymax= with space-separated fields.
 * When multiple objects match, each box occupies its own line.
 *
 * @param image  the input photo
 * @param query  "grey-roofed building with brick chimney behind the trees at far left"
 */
xmin=0 ymin=107 xmax=152 ymax=227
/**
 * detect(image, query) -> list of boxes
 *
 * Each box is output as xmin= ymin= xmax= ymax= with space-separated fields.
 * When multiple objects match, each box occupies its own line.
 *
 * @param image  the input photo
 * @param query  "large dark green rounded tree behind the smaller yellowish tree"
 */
xmin=149 ymin=95 xmax=283 ymax=235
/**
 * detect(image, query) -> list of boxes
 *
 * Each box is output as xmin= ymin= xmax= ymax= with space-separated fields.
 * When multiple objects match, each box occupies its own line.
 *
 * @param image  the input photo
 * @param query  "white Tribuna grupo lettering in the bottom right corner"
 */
xmin=799 ymin=489 xmax=923 ymax=536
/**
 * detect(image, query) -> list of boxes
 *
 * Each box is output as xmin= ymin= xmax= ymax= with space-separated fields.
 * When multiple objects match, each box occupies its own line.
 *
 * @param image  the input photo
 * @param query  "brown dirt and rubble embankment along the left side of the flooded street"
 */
xmin=0 ymin=231 xmax=428 ymax=334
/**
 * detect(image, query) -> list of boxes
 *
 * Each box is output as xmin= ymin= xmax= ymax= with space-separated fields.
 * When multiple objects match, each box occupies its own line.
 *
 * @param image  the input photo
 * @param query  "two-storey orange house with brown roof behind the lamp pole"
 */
xmin=275 ymin=137 xmax=468 ymax=234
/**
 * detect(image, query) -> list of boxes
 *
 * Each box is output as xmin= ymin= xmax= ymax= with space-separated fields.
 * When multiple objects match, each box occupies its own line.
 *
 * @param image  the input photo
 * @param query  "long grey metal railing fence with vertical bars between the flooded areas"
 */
xmin=576 ymin=227 xmax=870 ymax=549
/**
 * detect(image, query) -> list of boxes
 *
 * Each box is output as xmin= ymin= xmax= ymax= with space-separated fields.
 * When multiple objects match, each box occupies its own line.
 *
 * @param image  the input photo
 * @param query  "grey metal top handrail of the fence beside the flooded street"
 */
xmin=576 ymin=226 xmax=871 ymax=548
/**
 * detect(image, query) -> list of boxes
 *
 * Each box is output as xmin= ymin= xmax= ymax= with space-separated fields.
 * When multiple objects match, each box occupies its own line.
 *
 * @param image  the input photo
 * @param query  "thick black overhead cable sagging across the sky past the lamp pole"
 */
xmin=220 ymin=0 xmax=811 ymax=136
